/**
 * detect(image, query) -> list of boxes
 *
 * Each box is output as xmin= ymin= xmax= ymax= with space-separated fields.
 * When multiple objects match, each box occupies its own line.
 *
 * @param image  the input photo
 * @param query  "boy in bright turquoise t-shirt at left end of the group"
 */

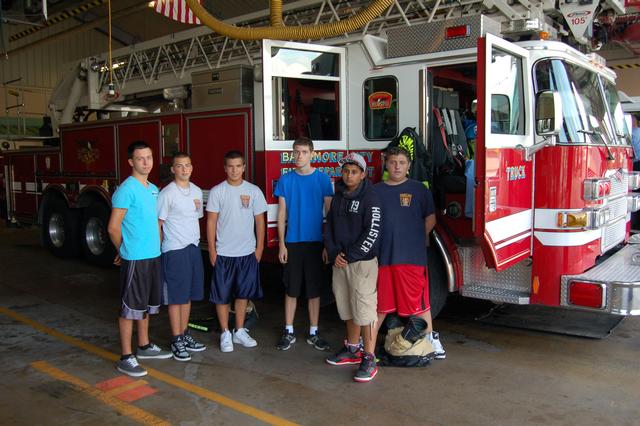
xmin=108 ymin=141 xmax=171 ymax=377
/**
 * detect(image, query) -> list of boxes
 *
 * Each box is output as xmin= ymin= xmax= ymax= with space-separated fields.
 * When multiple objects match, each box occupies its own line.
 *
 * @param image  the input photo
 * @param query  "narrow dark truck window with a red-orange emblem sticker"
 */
xmin=363 ymin=76 xmax=398 ymax=140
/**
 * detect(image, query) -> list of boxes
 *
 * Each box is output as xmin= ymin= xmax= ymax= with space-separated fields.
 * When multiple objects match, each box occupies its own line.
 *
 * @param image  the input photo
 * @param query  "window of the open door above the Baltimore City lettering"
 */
xmin=271 ymin=47 xmax=340 ymax=140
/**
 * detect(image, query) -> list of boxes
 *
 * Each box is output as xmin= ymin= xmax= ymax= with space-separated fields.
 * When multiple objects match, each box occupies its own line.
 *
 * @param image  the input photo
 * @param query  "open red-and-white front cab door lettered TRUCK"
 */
xmin=474 ymin=34 xmax=534 ymax=271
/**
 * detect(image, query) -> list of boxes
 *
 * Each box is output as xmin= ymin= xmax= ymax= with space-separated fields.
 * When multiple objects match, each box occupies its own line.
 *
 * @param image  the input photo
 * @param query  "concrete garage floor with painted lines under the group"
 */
xmin=0 ymin=228 xmax=640 ymax=425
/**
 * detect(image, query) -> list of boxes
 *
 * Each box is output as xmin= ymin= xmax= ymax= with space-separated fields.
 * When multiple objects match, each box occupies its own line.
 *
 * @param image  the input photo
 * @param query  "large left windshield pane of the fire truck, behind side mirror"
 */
xmin=535 ymin=59 xmax=619 ymax=145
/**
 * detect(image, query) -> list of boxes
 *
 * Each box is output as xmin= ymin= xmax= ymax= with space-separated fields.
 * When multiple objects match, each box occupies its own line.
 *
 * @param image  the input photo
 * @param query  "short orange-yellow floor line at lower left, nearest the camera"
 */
xmin=31 ymin=361 xmax=170 ymax=425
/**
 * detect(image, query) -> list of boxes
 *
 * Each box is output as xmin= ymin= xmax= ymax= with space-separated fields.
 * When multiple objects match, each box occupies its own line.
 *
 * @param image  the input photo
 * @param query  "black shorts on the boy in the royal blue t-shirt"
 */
xmin=283 ymin=241 xmax=324 ymax=299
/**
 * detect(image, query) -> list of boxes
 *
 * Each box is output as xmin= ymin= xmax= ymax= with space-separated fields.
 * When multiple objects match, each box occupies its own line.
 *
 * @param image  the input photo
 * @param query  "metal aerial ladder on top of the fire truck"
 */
xmin=86 ymin=0 xmax=543 ymax=99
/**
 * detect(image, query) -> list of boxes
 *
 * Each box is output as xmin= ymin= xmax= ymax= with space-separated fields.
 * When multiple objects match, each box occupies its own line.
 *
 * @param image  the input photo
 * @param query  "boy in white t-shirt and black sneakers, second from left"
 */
xmin=158 ymin=152 xmax=206 ymax=361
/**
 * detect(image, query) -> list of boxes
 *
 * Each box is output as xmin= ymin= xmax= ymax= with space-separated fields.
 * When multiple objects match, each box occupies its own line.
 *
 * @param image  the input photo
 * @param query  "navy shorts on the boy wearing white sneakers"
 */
xmin=211 ymin=253 xmax=262 ymax=305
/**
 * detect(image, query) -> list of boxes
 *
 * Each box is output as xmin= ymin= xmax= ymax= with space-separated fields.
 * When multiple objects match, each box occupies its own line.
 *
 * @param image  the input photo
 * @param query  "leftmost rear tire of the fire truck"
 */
xmin=42 ymin=197 xmax=80 ymax=257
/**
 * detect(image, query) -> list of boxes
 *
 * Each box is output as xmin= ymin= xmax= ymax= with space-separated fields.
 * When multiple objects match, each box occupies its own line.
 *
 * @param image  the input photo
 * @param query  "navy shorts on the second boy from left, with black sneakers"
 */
xmin=162 ymin=244 xmax=204 ymax=305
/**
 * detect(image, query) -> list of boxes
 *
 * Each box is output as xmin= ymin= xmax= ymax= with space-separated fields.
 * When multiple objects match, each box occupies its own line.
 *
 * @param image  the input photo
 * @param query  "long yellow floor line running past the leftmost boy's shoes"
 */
xmin=0 ymin=306 xmax=296 ymax=425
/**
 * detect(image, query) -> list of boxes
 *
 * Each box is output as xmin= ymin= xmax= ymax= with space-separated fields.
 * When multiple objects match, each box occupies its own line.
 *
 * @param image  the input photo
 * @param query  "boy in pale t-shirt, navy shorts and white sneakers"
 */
xmin=207 ymin=151 xmax=267 ymax=352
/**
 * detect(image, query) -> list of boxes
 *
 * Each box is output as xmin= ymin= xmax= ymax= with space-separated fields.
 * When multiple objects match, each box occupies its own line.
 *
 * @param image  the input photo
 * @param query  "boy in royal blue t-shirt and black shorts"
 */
xmin=275 ymin=137 xmax=333 ymax=351
